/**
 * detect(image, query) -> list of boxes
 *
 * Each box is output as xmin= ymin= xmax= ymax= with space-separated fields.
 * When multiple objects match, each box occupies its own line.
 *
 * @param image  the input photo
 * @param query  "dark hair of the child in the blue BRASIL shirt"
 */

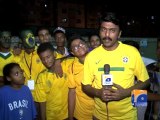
xmin=3 ymin=63 xmax=20 ymax=85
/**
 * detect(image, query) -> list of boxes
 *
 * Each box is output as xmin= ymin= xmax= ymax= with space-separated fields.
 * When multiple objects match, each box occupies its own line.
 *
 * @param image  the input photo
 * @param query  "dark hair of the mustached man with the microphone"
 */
xmin=100 ymin=12 xmax=121 ymax=29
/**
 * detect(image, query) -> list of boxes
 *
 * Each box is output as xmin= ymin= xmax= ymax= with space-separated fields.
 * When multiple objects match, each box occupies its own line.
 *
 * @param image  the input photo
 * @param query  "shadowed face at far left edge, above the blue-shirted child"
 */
xmin=0 ymin=31 xmax=11 ymax=49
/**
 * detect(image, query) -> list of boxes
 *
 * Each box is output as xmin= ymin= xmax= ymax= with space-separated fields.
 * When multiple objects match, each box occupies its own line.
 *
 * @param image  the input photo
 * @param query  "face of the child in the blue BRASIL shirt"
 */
xmin=9 ymin=66 xmax=25 ymax=85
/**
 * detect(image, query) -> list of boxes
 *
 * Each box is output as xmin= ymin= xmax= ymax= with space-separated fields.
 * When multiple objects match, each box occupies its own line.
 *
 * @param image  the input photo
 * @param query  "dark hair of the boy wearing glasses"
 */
xmin=68 ymin=34 xmax=85 ymax=52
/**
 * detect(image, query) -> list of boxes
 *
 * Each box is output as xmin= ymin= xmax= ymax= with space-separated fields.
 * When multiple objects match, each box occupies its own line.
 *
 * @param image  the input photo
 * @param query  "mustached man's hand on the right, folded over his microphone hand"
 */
xmin=106 ymin=83 xmax=128 ymax=101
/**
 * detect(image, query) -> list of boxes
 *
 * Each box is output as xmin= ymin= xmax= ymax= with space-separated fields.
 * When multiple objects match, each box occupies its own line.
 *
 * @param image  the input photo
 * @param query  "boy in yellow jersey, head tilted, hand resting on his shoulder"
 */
xmin=34 ymin=42 xmax=73 ymax=120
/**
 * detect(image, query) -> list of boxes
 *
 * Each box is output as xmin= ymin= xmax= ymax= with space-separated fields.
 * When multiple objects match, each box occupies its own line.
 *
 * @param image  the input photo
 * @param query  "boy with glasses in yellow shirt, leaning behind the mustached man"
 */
xmin=68 ymin=35 xmax=94 ymax=120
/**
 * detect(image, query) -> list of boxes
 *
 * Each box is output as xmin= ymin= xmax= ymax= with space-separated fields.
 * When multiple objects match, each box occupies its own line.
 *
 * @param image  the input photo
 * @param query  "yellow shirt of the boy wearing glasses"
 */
xmin=68 ymin=58 xmax=94 ymax=120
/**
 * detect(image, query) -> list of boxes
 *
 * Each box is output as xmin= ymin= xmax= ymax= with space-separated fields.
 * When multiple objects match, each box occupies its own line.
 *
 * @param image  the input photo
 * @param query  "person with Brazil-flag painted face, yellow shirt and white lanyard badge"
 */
xmin=19 ymin=30 xmax=45 ymax=91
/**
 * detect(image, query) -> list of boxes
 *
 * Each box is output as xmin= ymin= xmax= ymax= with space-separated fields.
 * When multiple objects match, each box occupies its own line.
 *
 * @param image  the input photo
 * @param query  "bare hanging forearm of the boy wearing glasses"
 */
xmin=68 ymin=88 xmax=76 ymax=120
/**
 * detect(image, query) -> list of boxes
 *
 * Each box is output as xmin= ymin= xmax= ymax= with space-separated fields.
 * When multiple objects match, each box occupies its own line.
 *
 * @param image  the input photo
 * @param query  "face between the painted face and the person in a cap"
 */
xmin=38 ymin=29 xmax=51 ymax=43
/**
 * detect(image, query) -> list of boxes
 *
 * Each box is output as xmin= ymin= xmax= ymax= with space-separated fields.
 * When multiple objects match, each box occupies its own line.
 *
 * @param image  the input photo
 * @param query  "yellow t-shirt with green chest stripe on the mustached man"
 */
xmin=82 ymin=42 xmax=149 ymax=120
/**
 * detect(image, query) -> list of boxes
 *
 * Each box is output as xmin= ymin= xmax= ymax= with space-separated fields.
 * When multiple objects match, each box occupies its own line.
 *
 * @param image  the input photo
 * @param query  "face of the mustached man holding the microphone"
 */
xmin=99 ymin=22 xmax=121 ymax=50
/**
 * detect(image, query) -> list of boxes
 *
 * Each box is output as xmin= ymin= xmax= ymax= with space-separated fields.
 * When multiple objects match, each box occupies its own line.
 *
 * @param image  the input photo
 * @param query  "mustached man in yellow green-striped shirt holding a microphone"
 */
xmin=82 ymin=12 xmax=149 ymax=120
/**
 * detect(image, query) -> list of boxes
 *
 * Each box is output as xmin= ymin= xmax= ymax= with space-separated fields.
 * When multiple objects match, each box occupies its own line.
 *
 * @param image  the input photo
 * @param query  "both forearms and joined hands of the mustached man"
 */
xmin=82 ymin=80 xmax=149 ymax=102
